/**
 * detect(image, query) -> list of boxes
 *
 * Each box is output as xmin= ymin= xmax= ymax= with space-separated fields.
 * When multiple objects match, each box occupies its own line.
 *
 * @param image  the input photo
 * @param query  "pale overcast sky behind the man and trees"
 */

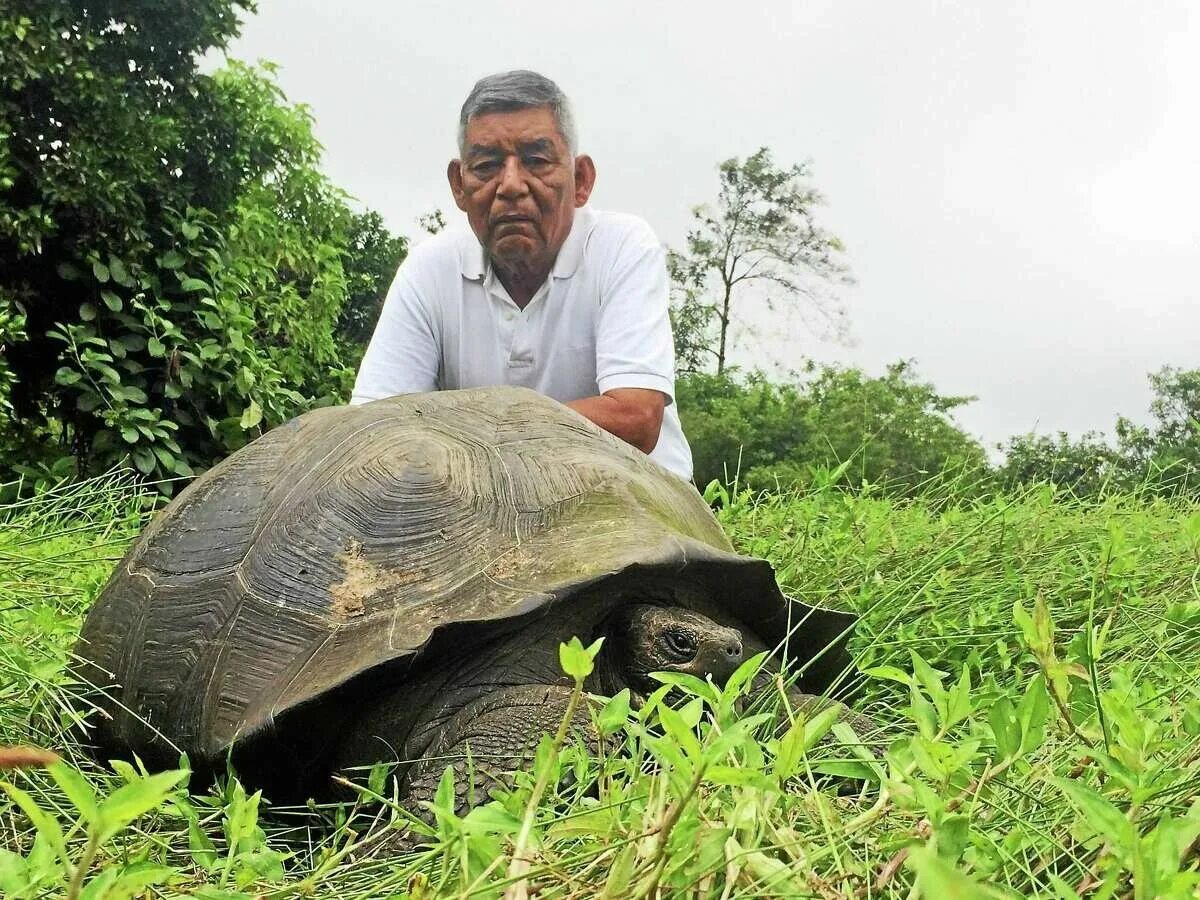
xmin=218 ymin=0 xmax=1200 ymax=451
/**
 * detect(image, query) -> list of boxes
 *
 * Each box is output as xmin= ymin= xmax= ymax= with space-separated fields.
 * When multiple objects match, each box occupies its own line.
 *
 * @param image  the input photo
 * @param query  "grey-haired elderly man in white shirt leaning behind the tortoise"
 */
xmin=350 ymin=71 xmax=691 ymax=479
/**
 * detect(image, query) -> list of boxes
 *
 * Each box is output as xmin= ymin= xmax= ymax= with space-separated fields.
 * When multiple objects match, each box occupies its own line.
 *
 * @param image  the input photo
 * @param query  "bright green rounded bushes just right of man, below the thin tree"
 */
xmin=676 ymin=361 xmax=986 ymax=494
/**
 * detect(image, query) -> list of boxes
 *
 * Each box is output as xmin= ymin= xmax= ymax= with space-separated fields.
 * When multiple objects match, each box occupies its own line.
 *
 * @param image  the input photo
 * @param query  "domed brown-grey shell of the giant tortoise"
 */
xmin=77 ymin=388 xmax=853 ymax=764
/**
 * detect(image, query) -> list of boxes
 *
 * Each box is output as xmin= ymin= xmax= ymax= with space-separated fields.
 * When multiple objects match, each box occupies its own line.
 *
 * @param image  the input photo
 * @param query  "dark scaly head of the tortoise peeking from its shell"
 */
xmin=600 ymin=604 xmax=742 ymax=696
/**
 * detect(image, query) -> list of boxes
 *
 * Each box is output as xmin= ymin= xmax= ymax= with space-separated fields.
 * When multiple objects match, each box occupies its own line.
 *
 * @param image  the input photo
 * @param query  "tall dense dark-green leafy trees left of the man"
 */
xmin=0 ymin=0 xmax=395 ymax=489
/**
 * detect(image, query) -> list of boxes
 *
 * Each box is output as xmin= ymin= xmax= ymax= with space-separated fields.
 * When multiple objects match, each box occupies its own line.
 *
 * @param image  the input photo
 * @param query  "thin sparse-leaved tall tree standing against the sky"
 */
xmin=668 ymin=148 xmax=850 ymax=374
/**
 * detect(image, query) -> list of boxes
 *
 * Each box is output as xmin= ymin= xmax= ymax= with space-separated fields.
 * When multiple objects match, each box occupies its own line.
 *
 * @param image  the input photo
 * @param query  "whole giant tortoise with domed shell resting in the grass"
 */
xmin=77 ymin=388 xmax=853 ymax=806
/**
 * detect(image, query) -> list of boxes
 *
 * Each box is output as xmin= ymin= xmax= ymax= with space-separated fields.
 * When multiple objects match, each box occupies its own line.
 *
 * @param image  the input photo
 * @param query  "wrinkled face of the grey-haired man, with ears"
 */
xmin=446 ymin=107 xmax=595 ymax=272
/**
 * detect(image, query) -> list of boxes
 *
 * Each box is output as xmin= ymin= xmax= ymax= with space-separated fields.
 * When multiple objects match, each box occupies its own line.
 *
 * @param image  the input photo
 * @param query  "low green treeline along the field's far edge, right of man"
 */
xmin=677 ymin=362 xmax=1200 ymax=499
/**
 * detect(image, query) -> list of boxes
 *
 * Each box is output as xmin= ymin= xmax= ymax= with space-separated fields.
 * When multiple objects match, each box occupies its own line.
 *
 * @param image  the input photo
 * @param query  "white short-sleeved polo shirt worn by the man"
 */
xmin=350 ymin=206 xmax=691 ymax=479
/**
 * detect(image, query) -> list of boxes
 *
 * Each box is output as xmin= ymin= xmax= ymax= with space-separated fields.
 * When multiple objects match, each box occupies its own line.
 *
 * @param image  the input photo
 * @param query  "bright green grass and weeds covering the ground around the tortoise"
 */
xmin=0 ymin=475 xmax=1200 ymax=900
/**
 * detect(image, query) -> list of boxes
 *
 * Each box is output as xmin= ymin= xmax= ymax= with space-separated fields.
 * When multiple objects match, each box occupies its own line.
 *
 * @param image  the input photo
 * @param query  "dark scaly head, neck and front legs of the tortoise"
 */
xmin=335 ymin=604 xmax=866 ymax=835
